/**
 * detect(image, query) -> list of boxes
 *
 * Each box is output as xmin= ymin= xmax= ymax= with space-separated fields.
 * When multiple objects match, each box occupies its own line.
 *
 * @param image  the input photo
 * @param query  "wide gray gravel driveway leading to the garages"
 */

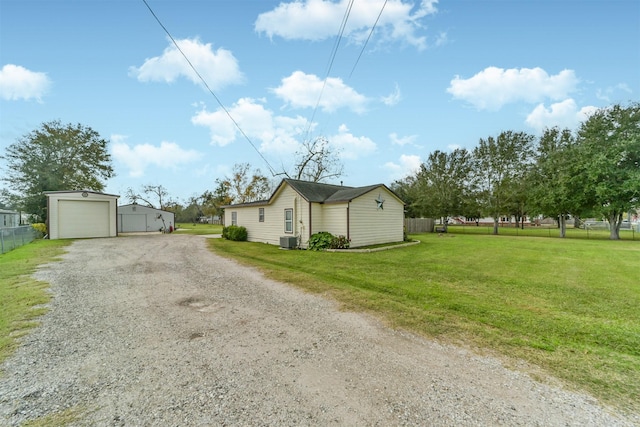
xmin=0 ymin=234 xmax=640 ymax=426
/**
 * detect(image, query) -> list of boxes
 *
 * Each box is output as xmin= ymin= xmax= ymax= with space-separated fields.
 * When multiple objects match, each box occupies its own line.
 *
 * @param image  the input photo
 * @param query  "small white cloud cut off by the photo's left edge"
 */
xmin=0 ymin=64 xmax=51 ymax=102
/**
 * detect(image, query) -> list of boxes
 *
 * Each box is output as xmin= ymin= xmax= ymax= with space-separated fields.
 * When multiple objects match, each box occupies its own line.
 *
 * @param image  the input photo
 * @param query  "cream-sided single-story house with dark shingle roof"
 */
xmin=224 ymin=179 xmax=404 ymax=248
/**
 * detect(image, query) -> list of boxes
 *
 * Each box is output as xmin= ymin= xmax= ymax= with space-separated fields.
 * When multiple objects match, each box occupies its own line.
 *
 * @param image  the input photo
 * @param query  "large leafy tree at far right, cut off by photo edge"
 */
xmin=575 ymin=103 xmax=640 ymax=240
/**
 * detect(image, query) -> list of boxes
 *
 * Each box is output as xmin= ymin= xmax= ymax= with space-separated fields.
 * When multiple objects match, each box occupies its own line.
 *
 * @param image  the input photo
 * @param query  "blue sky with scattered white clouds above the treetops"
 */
xmin=0 ymin=0 xmax=640 ymax=203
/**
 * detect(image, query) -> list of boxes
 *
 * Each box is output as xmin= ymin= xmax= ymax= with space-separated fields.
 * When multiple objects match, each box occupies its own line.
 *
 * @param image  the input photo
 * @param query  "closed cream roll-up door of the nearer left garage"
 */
xmin=58 ymin=200 xmax=109 ymax=239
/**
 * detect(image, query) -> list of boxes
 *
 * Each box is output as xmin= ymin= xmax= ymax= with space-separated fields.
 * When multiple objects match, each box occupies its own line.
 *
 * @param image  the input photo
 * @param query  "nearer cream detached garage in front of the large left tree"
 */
xmin=45 ymin=191 xmax=120 ymax=239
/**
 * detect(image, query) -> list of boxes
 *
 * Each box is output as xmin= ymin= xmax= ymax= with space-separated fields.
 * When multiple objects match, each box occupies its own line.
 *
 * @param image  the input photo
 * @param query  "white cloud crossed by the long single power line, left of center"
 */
xmin=191 ymin=98 xmax=307 ymax=153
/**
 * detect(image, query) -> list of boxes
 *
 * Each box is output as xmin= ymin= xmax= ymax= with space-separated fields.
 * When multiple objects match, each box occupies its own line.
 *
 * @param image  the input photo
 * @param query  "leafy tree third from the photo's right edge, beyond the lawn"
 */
xmin=471 ymin=131 xmax=534 ymax=234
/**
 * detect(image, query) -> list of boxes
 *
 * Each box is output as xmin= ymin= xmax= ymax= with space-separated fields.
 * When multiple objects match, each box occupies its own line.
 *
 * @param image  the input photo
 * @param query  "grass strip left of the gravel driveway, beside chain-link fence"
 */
xmin=0 ymin=240 xmax=70 ymax=363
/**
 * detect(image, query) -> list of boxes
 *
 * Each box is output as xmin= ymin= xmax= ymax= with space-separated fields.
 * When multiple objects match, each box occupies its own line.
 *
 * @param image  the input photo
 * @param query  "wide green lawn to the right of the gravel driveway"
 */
xmin=209 ymin=234 xmax=640 ymax=412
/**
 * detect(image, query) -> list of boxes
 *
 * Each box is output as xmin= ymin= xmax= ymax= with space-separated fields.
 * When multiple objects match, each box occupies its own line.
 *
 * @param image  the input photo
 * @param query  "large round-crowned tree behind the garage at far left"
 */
xmin=0 ymin=121 xmax=114 ymax=221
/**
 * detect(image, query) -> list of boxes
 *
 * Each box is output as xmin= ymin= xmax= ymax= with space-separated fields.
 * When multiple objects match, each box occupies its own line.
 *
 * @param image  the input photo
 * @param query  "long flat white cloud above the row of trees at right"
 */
xmin=447 ymin=67 xmax=579 ymax=110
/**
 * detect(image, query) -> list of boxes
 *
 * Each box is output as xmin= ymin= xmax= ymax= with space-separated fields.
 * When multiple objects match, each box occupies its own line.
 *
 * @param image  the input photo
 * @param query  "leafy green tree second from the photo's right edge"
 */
xmin=529 ymin=127 xmax=584 ymax=237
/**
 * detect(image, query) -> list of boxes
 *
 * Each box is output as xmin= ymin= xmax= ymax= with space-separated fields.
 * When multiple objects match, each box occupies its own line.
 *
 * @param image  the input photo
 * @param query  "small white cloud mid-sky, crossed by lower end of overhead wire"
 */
xmin=272 ymin=71 xmax=367 ymax=113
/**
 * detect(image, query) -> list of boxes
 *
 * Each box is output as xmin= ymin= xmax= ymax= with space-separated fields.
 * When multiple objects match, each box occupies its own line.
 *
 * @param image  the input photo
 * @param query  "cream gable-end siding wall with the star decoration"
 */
xmin=349 ymin=187 xmax=404 ymax=248
